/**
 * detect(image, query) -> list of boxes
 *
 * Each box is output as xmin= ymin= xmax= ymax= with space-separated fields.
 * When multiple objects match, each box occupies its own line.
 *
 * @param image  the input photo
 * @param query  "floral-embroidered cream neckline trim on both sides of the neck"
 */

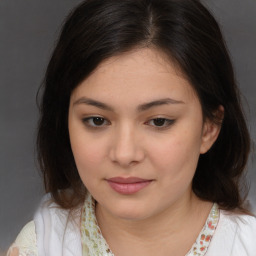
xmin=81 ymin=194 xmax=219 ymax=256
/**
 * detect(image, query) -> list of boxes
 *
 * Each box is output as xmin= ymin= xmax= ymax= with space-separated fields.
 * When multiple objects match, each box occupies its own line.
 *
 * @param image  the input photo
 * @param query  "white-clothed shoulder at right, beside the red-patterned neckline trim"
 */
xmin=207 ymin=210 xmax=256 ymax=256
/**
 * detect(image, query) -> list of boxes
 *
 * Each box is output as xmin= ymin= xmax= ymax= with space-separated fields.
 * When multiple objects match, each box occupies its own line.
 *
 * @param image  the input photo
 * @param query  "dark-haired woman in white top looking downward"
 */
xmin=9 ymin=0 xmax=256 ymax=256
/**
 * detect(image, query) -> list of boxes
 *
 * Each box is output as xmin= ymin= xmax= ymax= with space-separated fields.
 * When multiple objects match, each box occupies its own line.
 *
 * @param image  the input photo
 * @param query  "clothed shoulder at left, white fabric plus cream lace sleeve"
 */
xmin=7 ymin=194 xmax=82 ymax=256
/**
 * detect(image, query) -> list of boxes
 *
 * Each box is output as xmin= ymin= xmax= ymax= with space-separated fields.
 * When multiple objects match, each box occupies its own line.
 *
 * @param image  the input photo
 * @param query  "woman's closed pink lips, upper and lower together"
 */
xmin=107 ymin=177 xmax=152 ymax=195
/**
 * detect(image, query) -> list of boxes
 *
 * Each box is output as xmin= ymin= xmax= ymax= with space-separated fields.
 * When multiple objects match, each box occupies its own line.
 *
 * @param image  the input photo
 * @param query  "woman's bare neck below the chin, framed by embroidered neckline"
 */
xmin=96 ymin=193 xmax=212 ymax=255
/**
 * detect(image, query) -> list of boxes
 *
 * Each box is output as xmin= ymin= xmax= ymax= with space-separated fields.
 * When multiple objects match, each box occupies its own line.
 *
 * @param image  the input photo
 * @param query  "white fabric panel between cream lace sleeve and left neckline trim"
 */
xmin=34 ymin=194 xmax=81 ymax=256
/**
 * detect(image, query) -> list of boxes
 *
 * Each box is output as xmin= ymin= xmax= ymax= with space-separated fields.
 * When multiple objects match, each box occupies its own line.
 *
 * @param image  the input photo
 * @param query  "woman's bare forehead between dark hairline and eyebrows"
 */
xmin=72 ymin=48 xmax=199 ymax=104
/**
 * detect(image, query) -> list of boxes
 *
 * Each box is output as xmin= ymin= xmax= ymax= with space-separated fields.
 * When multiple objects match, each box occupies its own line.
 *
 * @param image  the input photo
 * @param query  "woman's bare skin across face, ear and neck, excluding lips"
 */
xmin=68 ymin=48 xmax=220 ymax=256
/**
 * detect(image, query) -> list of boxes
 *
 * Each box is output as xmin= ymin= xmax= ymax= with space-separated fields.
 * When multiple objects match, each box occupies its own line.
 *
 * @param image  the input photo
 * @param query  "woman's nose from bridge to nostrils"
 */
xmin=110 ymin=125 xmax=145 ymax=167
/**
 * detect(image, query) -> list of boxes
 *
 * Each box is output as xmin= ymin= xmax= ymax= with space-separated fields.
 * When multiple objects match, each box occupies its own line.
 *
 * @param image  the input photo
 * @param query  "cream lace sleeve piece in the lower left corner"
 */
xmin=7 ymin=221 xmax=38 ymax=256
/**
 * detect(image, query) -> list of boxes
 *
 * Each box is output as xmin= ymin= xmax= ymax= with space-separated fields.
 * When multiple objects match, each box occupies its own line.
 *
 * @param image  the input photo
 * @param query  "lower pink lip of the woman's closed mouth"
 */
xmin=108 ymin=180 xmax=152 ymax=195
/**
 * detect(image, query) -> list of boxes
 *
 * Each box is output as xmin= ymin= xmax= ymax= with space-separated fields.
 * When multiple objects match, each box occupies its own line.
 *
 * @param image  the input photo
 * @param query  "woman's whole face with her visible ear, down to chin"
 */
xmin=69 ymin=49 xmax=218 ymax=220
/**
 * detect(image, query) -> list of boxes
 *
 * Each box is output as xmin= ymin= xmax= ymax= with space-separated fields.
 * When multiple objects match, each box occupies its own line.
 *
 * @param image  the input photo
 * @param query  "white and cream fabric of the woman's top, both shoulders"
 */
xmin=7 ymin=195 xmax=256 ymax=256
